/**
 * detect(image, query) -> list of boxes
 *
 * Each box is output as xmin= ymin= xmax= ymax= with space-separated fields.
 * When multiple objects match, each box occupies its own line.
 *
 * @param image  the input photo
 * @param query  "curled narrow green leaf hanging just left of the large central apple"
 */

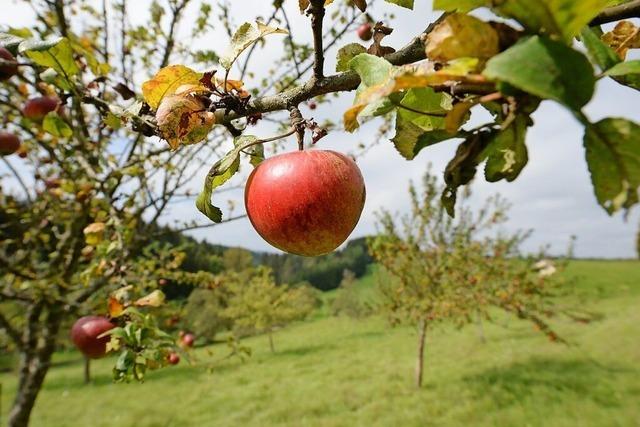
xmin=196 ymin=135 xmax=258 ymax=222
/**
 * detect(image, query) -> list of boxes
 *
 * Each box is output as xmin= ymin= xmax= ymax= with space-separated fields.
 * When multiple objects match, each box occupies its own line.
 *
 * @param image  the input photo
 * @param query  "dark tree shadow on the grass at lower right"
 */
xmin=463 ymin=358 xmax=640 ymax=407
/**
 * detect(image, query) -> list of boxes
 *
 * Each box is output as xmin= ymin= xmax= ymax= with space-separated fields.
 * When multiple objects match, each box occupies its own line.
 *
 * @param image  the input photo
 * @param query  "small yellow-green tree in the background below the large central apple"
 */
xmin=222 ymin=267 xmax=315 ymax=352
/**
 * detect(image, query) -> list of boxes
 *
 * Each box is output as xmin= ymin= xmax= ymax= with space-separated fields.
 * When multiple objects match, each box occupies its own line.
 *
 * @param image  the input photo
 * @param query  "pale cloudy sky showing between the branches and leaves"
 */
xmin=5 ymin=0 xmax=640 ymax=257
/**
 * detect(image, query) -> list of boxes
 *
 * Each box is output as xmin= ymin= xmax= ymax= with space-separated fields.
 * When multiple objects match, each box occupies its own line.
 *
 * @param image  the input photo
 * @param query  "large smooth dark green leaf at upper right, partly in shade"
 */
xmin=483 ymin=36 xmax=595 ymax=110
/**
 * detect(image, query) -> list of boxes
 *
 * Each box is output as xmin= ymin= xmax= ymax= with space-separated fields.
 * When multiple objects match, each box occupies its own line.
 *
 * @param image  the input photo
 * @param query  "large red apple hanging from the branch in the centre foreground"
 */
xmin=244 ymin=150 xmax=365 ymax=256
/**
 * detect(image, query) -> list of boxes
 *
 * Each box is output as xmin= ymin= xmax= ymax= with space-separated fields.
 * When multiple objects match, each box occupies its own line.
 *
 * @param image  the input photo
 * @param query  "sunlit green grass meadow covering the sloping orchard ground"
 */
xmin=0 ymin=261 xmax=640 ymax=427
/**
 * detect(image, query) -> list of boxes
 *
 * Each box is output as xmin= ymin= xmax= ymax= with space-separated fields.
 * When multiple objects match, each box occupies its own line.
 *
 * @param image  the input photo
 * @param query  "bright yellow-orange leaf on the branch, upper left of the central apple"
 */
xmin=142 ymin=65 xmax=202 ymax=110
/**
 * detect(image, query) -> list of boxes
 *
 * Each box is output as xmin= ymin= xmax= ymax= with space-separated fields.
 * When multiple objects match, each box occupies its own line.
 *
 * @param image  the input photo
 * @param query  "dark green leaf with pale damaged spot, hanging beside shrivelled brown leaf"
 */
xmin=482 ymin=115 xmax=530 ymax=182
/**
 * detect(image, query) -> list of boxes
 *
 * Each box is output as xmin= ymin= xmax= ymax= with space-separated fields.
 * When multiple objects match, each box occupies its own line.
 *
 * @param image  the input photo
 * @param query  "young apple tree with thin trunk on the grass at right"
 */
xmin=369 ymin=173 xmax=576 ymax=387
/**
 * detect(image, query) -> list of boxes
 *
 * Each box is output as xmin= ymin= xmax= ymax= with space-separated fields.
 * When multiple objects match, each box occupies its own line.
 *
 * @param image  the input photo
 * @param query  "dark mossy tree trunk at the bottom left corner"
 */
xmin=7 ymin=312 xmax=60 ymax=427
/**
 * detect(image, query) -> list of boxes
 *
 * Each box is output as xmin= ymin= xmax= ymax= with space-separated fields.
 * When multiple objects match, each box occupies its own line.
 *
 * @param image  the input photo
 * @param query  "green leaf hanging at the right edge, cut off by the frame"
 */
xmin=584 ymin=118 xmax=640 ymax=214
